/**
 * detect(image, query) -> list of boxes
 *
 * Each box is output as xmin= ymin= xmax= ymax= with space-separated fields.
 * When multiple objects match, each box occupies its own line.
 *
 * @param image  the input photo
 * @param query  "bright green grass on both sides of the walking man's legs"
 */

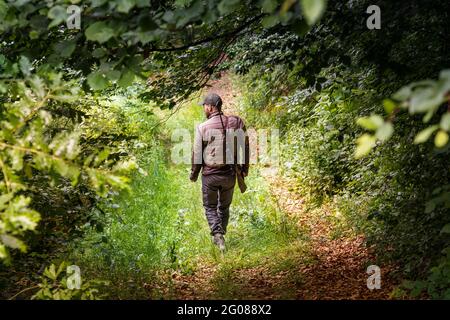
xmin=71 ymin=101 xmax=310 ymax=298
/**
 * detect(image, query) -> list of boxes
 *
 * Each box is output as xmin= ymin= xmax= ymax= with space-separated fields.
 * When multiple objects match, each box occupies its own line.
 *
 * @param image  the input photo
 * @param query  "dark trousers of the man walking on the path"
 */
xmin=202 ymin=174 xmax=236 ymax=235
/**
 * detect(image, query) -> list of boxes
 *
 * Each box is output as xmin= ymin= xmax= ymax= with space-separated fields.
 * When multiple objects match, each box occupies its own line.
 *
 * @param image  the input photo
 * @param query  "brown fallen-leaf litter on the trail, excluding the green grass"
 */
xmin=173 ymin=75 xmax=394 ymax=299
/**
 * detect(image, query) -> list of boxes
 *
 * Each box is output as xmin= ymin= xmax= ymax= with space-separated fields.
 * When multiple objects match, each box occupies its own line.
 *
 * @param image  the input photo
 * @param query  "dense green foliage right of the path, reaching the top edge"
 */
xmin=230 ymin=1 xmax=450 ymax=298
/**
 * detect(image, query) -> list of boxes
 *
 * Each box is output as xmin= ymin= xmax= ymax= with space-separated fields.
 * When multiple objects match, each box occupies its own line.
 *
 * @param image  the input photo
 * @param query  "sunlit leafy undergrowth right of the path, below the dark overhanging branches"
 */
xmin=236 ymin=65 xmax=450 ymax=298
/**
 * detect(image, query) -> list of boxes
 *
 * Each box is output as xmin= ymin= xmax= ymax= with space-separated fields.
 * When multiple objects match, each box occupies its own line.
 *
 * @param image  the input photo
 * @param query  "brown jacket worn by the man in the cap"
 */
xmin=191 ymin=112 xmax=250 ymax=180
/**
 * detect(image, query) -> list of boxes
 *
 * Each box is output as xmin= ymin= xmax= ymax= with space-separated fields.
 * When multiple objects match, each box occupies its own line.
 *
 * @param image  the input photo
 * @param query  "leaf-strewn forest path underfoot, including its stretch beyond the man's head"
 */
xmin=163 ymin=75 xmax=394 ymax=299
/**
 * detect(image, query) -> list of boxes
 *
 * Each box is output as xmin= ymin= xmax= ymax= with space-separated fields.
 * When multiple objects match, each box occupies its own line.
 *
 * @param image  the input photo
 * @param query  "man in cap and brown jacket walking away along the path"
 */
xmin=190 ymin=93 xmax=249 ymax=251
